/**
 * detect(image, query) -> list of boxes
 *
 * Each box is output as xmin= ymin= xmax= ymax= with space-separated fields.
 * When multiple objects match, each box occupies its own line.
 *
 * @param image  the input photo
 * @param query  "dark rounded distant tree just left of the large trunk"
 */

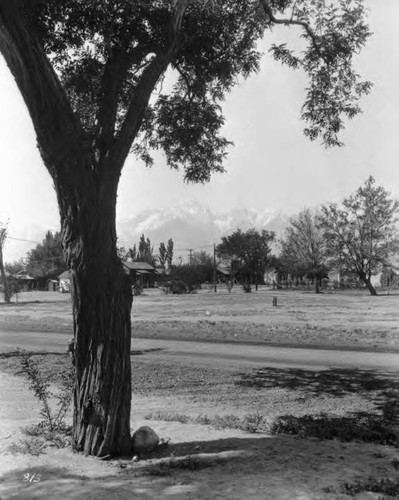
xmin=26 ymin=231 xmax=67 ymax=279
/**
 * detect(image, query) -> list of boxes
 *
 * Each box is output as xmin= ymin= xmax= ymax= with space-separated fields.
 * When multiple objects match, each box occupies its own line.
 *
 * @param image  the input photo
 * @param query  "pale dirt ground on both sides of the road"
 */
xmin=0 ymin=290 xmax=399 ymax=500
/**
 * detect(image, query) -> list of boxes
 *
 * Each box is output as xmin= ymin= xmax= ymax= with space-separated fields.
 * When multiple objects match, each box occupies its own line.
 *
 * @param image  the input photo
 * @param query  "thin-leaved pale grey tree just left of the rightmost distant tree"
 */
xmin=280 ymin=209 xmax=327 ymax=293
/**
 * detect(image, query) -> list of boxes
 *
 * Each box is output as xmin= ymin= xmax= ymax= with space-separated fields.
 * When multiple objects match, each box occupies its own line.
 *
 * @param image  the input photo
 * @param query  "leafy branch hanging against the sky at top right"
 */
xmin=268 ymin=0 xmax=371 ymax=146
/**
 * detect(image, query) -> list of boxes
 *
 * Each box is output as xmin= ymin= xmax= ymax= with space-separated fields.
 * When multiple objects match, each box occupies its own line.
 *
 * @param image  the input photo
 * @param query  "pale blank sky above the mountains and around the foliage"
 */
xmin=0 ymin=0 xmax=399 ymax=260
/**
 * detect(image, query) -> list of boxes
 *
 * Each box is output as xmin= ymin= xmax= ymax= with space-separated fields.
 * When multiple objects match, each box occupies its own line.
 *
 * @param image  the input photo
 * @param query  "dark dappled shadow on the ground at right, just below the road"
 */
xmin=235 ymin=367 xmax=399 ymax=397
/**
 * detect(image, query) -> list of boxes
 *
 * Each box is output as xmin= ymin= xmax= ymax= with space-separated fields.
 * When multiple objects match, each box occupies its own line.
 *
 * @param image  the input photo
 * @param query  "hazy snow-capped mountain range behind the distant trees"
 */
xmin=117 ymin=202 xmax=288 ymax=255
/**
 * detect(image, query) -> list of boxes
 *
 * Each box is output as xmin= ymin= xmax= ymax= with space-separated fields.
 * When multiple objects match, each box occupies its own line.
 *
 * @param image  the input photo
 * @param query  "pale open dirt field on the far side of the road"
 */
xmin=0 ymin=287 xmax=399 ymax=350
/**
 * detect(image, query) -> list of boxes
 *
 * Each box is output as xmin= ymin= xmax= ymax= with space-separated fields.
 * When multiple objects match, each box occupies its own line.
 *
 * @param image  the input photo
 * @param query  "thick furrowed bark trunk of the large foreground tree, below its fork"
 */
xmin=56 ymin=170 xmax=132 ymax=456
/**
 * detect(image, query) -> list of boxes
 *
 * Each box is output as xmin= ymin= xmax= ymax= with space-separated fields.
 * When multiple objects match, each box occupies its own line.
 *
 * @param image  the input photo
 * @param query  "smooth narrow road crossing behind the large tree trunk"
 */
xmin=0 ymin=331 xmax=399 ymax=373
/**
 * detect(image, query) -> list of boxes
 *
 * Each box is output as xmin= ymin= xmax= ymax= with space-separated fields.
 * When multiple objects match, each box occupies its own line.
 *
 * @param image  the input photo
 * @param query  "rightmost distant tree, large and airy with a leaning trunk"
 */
xmin=320 ymin=176 xmax=399 ymax=295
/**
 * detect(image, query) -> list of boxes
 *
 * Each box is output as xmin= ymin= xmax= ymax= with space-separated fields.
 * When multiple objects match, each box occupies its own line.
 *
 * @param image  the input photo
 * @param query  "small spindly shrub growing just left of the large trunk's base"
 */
xmin=21 ymin=352 xmax=74 ymax=440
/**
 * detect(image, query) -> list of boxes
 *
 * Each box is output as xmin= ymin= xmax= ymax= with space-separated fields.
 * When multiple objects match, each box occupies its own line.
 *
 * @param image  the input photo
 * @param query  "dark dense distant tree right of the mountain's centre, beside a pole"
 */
xmin=216 ymin=229 xmax=275 ymax=289
